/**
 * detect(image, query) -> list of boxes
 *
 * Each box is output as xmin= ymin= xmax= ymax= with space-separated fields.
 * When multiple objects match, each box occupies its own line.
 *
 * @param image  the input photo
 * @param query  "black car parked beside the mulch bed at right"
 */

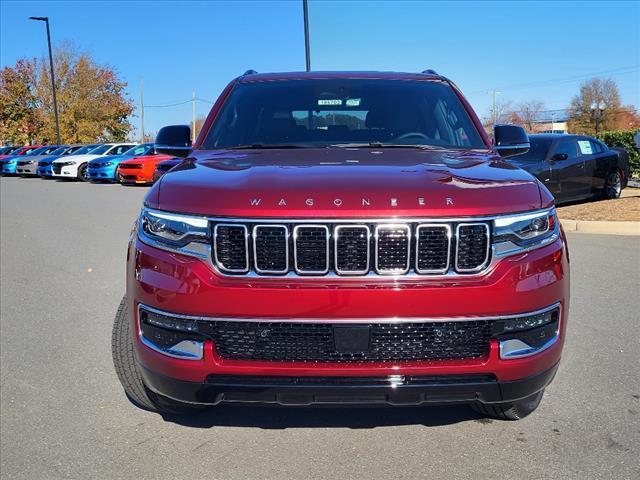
xmin=507 ymin=134 xmax=629 ymax=203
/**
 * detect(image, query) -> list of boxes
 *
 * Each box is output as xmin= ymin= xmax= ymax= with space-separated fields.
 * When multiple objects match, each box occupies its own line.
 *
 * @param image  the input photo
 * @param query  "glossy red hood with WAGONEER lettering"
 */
xmin=151 ymin=148 xmax=541 ymax=218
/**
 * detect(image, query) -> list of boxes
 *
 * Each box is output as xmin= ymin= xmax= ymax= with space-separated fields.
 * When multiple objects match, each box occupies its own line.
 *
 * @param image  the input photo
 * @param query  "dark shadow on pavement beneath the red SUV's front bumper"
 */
xmin=158 ymin=405 xmax=482 ymax=430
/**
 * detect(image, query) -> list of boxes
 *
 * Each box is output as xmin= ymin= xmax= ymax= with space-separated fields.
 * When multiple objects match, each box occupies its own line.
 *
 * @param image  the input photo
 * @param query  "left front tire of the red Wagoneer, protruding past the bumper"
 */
xmin=111 ymin=297 xmax=206 ymax=415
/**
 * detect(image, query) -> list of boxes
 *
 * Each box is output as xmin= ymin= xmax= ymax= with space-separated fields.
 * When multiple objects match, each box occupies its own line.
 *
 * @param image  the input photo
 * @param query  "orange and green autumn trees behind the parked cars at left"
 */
xmin=0 ymin=45 xmax=133 ymax=143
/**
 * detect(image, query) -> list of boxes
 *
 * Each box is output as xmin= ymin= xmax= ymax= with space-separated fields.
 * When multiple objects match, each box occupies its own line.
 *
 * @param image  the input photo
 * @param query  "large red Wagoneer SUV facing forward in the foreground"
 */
xmin=112 ymin=71 xmax=569 ymax=419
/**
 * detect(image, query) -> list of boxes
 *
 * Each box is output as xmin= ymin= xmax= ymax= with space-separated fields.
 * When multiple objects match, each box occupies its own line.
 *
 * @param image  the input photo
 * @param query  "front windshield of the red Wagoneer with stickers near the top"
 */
xmin=203 ymin=79 xmax=487 ymax=149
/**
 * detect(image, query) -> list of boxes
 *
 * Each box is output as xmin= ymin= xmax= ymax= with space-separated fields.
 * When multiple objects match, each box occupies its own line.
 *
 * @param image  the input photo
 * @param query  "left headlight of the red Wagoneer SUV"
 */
xmin=138 ymin=208 xmax=211 ymax=258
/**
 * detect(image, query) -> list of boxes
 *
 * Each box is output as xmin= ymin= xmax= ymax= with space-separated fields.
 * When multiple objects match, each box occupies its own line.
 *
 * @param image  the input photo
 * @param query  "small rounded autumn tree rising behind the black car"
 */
xmin=569 ymin=78 xmax=621 ymax=135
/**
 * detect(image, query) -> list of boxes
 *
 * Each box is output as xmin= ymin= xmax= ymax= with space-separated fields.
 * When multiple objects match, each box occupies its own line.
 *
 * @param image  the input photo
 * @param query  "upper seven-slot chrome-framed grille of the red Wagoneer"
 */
xmin=213 ymin=222 xmax=491 ymax=276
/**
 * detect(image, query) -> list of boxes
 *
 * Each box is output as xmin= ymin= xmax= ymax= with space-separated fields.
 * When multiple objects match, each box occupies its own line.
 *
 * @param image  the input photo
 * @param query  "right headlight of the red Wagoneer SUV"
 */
xmin=493 ymin=208 xmax=559 ymax=256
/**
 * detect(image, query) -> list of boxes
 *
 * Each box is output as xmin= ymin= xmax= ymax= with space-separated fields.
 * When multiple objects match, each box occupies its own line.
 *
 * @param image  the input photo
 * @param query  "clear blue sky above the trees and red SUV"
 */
xmin=0 ymin=0 xmax=640 ymax=137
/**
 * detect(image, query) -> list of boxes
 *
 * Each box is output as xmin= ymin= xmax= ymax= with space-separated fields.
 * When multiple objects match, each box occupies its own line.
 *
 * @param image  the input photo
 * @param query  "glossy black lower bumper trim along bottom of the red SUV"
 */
xmin=142 ymin=364 xmax=558 ymax=406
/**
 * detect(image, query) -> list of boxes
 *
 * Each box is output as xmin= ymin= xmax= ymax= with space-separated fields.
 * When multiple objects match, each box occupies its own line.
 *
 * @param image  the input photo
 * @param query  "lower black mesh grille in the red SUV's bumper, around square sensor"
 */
xmin=200 ymin=320 xmax=491 ymax=362
